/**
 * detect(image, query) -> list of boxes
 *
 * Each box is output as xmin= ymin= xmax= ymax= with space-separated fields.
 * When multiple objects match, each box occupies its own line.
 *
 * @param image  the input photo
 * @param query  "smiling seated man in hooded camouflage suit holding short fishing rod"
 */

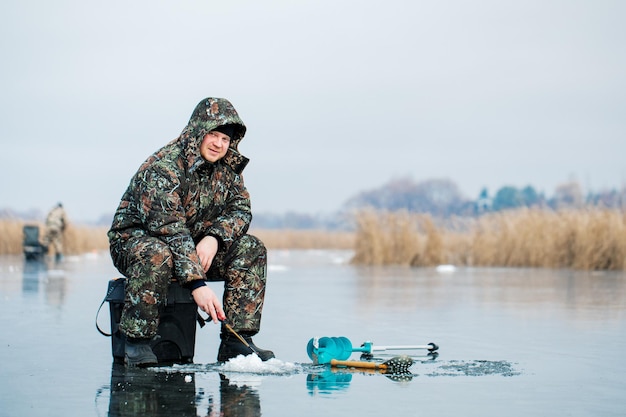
xmin=108 ymin=98 xmax=274 ymax=366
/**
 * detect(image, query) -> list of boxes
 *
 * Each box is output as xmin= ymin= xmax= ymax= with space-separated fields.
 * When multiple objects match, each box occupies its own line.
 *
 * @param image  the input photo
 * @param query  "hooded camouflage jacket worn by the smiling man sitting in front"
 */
xmin=108 ymin=98 xmax=252 ymax=284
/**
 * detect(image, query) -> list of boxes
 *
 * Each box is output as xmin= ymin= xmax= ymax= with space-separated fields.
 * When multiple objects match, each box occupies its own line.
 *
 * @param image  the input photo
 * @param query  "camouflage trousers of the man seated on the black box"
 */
xmin=111 ymin=235 xmax=267 ymax=338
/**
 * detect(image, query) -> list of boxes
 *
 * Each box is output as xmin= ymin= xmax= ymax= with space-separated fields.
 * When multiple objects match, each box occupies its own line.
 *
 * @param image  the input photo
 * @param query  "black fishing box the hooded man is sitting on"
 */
xmin=105 ymin=278 xmax=198 ymax=364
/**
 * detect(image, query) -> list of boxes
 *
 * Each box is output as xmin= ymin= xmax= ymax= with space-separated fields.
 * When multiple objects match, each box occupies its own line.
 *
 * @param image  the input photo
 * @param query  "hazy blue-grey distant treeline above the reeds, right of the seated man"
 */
xmin=253 ymin=178 xmax=626 ymax=231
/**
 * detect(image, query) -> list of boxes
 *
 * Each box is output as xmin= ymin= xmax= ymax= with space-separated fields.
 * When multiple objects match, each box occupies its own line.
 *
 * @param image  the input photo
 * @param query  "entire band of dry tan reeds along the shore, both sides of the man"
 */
xmin=0 ymin=208 xmax=626 ymax=270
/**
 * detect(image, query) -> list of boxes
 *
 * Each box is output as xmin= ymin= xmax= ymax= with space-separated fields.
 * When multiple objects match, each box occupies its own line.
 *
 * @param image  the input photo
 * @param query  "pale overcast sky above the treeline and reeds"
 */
xmin=0 ymin=0 xmax=626 ymax=221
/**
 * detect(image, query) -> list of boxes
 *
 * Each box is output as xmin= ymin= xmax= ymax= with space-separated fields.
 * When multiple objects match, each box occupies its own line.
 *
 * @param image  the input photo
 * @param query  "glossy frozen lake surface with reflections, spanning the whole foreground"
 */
xmin=0 ymin=251 xmax=626 ymax=417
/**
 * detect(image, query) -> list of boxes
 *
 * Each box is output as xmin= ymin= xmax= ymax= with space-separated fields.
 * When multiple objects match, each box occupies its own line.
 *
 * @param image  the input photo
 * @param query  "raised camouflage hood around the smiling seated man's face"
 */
xmin=178 ymin=97 xmax=249 ymax=174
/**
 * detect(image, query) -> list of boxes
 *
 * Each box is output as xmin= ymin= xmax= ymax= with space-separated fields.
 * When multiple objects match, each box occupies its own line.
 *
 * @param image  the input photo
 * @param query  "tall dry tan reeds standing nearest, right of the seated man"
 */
xmin=353 ymin=208 xmax=626 ymax=270
